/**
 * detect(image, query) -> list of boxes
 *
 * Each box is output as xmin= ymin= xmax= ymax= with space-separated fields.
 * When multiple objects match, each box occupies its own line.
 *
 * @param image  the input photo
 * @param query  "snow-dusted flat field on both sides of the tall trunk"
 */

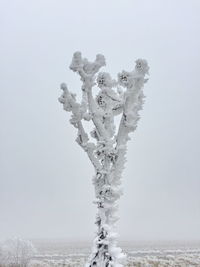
xmin=29 ymin=241 xmax=200 ymax=267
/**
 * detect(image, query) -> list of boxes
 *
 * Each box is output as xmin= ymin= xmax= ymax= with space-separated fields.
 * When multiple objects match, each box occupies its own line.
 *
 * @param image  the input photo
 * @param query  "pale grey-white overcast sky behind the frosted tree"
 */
xmin=0 ymin=0 xmax=200 ymax=241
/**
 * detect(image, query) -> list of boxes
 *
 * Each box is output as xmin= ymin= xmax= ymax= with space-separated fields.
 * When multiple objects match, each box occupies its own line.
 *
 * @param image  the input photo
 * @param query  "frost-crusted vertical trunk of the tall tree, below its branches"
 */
xmin=86 ymin=156 xmax=125 ymax=267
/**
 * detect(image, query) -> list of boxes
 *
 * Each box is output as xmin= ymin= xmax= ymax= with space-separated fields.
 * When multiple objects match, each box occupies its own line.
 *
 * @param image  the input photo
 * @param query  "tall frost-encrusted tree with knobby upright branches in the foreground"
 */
xmin=59 ymin=52 xmax=149 ymax=267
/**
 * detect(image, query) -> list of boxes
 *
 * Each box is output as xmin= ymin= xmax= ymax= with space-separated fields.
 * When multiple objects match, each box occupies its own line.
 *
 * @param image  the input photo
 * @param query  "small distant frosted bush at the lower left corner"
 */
xmin=0 ymin=238 xmax=36 ymax=267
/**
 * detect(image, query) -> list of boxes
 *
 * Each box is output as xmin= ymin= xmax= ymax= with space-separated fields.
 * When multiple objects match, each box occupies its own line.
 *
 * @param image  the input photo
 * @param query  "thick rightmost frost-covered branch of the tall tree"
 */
xmin=111 ymin=59 xmax=149 ymax=188
